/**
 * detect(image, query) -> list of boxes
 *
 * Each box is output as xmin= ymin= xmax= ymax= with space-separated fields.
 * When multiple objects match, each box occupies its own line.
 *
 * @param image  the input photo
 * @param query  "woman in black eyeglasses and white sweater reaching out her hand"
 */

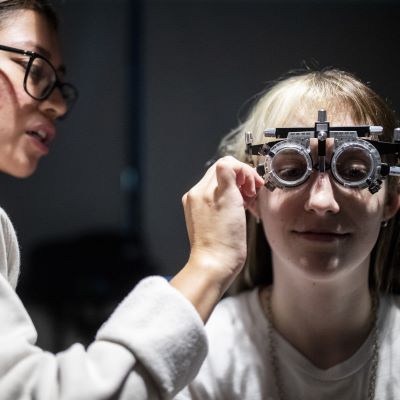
xmin=0 ymin=0 xmax=263 ymax=400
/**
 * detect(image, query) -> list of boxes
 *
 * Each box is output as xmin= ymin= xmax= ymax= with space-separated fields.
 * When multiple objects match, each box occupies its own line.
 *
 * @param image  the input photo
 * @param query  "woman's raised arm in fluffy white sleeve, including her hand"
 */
xmin=0 ymin=157 xmax=262 ymax=400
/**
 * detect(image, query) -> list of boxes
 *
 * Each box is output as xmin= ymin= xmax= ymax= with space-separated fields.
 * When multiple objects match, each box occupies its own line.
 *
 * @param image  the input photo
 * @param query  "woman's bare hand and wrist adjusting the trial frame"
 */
xmin=171 ymin=156 xmax=264 ymax=320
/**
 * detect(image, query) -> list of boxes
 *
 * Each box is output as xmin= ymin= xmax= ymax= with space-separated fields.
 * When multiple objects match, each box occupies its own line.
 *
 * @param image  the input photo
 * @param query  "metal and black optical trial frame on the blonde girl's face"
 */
xmin=245 ymin=110 xmax=400 ymax=193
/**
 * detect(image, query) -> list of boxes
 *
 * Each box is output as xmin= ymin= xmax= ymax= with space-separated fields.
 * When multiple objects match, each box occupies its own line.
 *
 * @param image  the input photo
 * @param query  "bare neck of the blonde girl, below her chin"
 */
xmin=260 ymin=258 xmax=373 ymax=369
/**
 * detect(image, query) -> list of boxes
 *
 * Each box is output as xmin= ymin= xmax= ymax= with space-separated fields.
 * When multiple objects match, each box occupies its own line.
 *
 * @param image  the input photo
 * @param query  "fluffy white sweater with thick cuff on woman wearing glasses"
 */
xmin=0 ymin=209 xmax=207 ymax=400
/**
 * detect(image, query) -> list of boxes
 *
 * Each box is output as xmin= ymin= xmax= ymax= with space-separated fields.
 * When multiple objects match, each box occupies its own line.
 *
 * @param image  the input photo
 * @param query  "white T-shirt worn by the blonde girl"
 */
xmin=176 ymin=289 xmax=400 ymax=400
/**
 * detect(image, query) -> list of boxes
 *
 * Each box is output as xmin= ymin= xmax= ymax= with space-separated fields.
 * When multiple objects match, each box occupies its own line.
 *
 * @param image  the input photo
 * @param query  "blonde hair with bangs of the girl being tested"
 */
xmin=218 ymin=68 xmax=400 ymax=293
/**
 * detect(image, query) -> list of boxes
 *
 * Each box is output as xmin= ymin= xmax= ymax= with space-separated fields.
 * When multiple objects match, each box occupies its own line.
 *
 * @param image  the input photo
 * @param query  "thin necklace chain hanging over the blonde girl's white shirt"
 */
xmin=261 ymin=287 xmax=379 ymax=400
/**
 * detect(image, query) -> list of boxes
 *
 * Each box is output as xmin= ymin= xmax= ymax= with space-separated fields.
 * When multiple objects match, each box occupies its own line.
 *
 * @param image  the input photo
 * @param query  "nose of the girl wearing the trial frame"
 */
xmin=304 ymin=172 xmax=340 ymax=215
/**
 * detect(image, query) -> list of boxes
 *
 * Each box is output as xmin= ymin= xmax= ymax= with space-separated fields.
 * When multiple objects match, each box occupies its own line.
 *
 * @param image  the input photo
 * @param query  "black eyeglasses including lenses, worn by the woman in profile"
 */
xmin=0 ymin=45 xmax=78 ymax=112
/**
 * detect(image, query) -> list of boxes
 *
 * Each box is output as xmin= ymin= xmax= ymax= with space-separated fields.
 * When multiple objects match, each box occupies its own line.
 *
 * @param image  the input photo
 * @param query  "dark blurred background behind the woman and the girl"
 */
xmin=0 ymin=0 xmax=400 ymax=351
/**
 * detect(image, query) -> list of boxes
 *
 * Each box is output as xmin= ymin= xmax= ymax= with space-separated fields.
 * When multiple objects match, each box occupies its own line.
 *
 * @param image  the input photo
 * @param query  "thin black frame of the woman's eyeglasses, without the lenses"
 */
xmin=0 ymin=44 xmax=78 ymax=107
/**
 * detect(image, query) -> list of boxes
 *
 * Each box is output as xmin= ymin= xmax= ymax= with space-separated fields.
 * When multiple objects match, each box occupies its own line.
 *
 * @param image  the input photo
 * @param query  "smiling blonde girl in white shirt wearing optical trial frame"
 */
xmin=177 ymin=69 xmax=400 ymax=400
